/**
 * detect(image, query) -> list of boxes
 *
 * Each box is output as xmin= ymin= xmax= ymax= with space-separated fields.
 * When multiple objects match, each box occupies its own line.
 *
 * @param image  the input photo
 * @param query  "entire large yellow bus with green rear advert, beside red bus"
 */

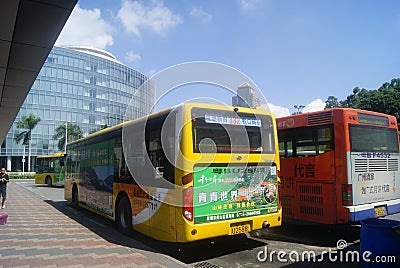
xmin=65 ymin=103 xmax=282 ymax=242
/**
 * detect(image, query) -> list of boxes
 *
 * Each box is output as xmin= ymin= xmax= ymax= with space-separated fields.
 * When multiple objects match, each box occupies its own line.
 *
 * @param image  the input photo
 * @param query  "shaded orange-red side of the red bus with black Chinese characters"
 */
xmin=280 ymin=125 xmax=336 ymax=223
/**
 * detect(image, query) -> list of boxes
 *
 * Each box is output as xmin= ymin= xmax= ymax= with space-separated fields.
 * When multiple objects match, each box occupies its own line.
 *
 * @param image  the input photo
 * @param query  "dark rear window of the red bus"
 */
xmin=349 ymin=125 xmax=399 ymax=153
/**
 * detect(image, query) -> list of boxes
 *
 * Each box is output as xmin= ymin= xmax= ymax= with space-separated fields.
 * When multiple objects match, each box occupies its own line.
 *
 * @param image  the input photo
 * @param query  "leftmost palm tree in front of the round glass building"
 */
xmin=15 ymin=114 xmax=40 ymax=172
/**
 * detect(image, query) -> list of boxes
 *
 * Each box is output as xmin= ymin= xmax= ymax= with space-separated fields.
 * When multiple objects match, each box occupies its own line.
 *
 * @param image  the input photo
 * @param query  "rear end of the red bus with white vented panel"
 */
xmin=343 ymin=111 xmax=400 ymax=221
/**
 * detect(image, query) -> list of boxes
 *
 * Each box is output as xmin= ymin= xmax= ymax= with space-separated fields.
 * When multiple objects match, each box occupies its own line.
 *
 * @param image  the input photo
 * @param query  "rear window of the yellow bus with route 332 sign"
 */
xmin=192 ymin=108 xmax=275 ymax=153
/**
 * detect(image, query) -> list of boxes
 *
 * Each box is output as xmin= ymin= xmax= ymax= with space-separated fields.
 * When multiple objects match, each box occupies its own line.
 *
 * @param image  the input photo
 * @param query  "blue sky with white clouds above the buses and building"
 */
xmin=56 ymin=0 xmax=400 ymax=116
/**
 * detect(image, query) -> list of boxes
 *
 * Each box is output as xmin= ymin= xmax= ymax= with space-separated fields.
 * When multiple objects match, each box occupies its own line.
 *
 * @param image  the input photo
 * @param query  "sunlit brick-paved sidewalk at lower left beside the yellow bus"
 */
xmin=0 ymin=182 xmax=182 ymax=268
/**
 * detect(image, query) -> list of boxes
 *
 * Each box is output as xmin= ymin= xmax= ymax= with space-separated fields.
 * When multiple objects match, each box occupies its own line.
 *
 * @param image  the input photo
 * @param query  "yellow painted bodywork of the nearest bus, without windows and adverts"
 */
xmin=65 ymin=103 xmax=282 ymax=242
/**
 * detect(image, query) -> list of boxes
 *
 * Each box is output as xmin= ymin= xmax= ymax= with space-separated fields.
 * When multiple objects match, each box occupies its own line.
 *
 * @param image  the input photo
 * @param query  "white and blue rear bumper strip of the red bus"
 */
xmin=347 ymin=199 xmax=400 ymax=222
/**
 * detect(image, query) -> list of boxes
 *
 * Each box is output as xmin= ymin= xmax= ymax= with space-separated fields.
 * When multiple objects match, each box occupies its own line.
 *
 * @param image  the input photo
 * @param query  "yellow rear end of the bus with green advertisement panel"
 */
xmin=177 ymin=104 xmax=281 ymax=241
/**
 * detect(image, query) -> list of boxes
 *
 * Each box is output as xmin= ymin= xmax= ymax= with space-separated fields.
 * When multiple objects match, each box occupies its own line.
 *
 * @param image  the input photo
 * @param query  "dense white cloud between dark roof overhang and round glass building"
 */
xmin=56 ymin=4 xmax=114 ymax=49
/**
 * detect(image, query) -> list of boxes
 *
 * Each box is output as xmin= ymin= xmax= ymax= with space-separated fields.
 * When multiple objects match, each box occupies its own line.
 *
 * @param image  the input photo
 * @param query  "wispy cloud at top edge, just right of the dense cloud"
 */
xmin=117 ymin=0 xmax=182 ymax=36
